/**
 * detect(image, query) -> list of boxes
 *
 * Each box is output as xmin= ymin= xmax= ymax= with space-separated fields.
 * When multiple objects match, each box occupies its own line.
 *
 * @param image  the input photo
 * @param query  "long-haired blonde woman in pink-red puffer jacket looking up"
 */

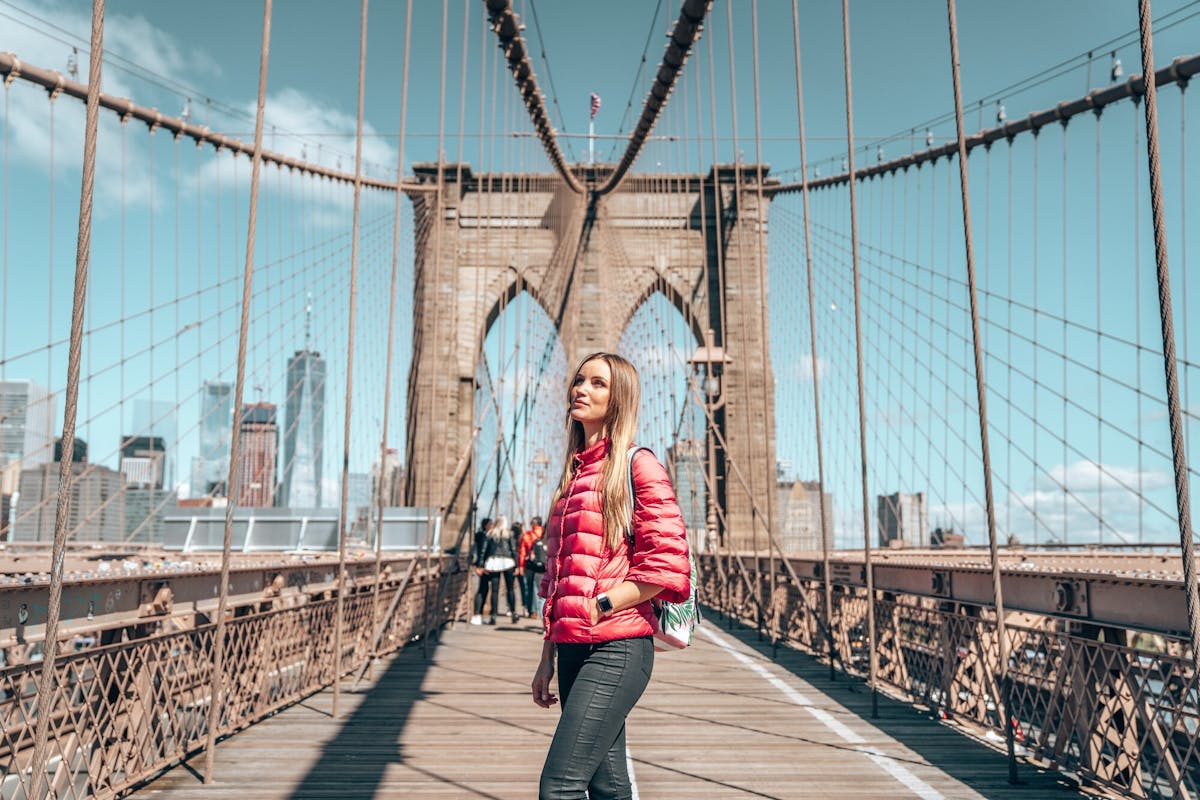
xmin=532 ymin=353 xmax=691 ymax=800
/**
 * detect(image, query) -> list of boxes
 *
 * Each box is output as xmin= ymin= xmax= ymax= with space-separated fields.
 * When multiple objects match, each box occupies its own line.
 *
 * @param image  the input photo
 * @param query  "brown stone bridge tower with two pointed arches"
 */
xmin=406 ymin=164 xmax=775 ymax=549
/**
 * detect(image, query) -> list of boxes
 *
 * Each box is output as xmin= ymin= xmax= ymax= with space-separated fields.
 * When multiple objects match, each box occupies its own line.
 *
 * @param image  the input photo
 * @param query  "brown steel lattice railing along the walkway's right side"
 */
xmin=700 ymin=554 xmax=1200 ymax=798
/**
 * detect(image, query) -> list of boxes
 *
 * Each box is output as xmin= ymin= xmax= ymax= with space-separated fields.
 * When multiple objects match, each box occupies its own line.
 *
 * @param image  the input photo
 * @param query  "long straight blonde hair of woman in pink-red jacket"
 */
xmin=550 ymin=353 xmax=642 ymax=549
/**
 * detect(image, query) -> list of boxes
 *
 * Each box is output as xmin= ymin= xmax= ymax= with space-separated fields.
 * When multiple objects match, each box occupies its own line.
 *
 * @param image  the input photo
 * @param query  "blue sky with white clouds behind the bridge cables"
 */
xmin=0 ymin=0 xmax=1200 ymax=537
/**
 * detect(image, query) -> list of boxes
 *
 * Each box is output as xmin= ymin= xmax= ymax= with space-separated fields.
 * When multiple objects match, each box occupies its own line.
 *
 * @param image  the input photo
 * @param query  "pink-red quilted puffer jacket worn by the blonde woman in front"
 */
xmin=538 ymin=439 xmax=691 ymax=643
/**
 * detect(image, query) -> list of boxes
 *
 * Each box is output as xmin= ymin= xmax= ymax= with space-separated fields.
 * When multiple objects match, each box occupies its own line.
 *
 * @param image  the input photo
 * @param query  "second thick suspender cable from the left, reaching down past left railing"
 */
xmin=204 ymin=0 xmax=271 ymax=783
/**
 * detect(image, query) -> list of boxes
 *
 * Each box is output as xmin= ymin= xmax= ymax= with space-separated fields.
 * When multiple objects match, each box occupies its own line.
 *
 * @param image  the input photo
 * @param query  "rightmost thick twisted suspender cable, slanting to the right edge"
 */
xmin=1138 ymin=0 xmax=1200 ymax=663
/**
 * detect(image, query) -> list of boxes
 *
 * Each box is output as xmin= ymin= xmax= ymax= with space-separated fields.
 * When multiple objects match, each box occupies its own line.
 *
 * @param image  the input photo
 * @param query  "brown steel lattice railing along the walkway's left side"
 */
xmin=0 ymin=555 xmax=468 ymax=798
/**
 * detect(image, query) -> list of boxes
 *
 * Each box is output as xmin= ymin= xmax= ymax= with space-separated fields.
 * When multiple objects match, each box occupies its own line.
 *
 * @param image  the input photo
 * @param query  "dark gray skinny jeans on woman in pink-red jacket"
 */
xmin=538 ymin=636 xmax=654 ymax=800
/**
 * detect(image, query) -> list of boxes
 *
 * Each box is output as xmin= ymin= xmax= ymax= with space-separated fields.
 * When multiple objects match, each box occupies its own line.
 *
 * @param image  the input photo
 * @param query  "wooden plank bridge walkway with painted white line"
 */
xmin=136 ymin=609 xmax=1096 ymax=800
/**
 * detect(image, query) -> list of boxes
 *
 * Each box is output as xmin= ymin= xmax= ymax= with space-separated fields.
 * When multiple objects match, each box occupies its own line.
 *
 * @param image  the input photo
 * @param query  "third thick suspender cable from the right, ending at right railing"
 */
xmin=840 ymin=0 xmax=880 ymax=717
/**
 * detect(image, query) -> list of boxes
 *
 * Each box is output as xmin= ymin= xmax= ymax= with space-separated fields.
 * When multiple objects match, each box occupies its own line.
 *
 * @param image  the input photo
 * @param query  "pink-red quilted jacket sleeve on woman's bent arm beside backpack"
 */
xmin=625 ymin=451 xmax=691 ymax=603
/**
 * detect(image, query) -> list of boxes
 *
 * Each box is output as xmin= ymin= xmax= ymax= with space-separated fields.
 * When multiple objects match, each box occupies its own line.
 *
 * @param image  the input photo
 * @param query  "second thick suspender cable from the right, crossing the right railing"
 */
xmin=946 ymin=0 xmax=1012 ymax=783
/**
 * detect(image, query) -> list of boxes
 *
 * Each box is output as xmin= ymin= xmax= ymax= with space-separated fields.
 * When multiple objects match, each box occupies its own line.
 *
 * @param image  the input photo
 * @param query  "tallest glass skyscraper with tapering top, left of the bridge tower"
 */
xmin=280 ymin=343 xmax=325 ymax=509
